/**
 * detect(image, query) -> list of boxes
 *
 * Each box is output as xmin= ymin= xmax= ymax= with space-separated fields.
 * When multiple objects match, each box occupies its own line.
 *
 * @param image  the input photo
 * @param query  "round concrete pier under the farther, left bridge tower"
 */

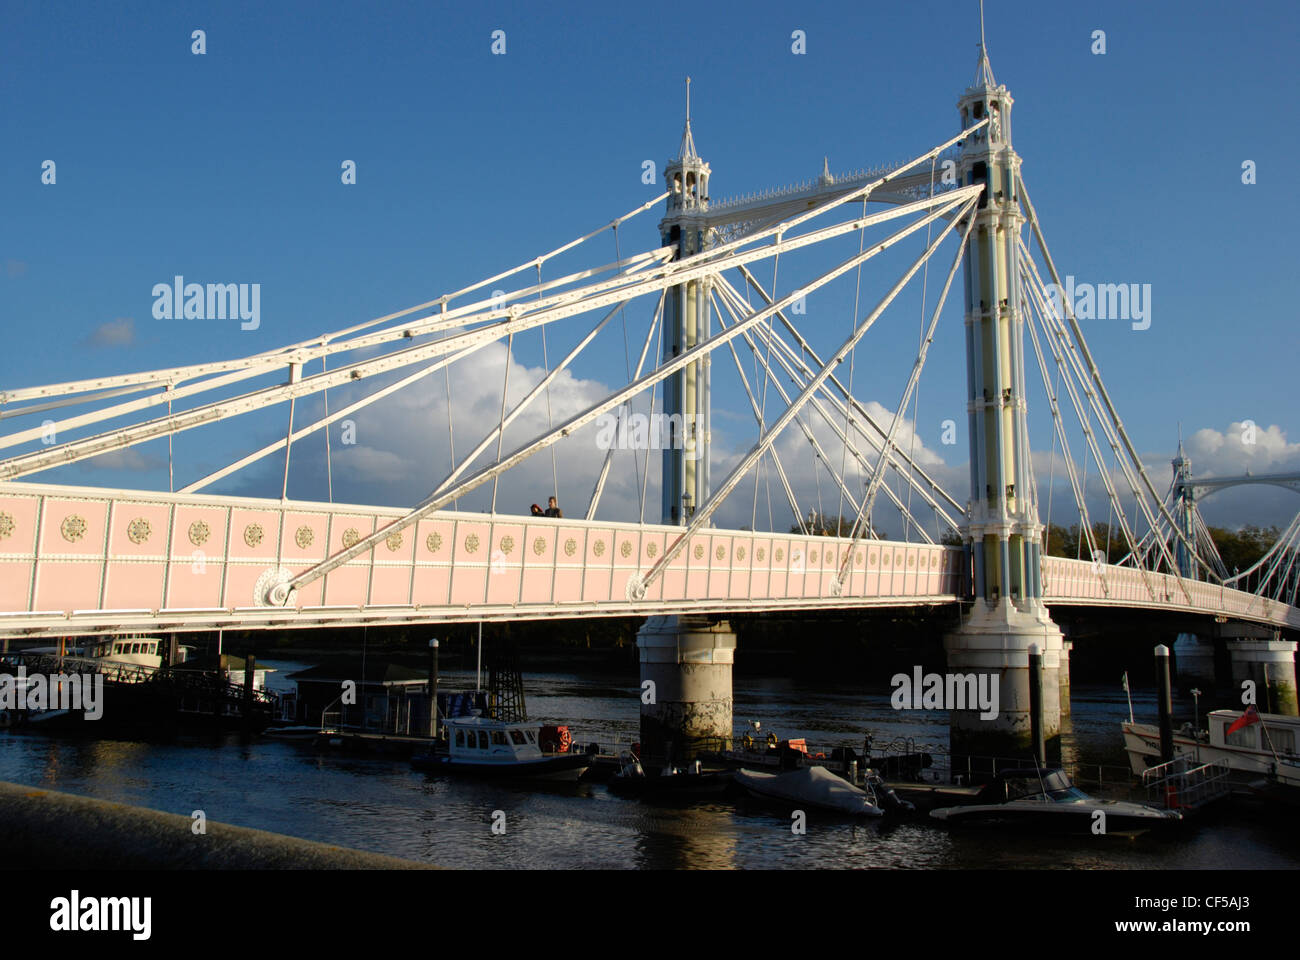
xmin=637 ymin=614 xmax=736 ymax=762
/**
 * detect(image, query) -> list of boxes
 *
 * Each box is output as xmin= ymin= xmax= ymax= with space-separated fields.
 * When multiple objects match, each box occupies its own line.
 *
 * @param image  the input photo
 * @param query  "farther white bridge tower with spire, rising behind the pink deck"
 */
xmin=659 ymin=77 xmax=712 ymax=524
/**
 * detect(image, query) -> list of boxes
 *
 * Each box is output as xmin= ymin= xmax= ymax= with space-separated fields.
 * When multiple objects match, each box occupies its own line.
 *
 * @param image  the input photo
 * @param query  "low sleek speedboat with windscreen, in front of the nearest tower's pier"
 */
xmin=930 ymin=767 xmax=1183 ymax=836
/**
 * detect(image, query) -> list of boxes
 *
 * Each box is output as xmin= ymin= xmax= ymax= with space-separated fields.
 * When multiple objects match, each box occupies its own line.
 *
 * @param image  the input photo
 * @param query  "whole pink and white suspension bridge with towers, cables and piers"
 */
xmin=0 ymin=31 xmax=1300 ymax=754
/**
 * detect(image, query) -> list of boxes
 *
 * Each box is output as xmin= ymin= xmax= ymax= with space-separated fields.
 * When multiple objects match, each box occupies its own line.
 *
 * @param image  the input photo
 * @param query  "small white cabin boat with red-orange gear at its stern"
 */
xmin=411 ymin=717 xmax=592 ymax=780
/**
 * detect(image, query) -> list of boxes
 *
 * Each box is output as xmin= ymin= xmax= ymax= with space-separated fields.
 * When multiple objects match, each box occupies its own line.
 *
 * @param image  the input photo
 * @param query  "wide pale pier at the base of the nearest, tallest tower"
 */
xmin=944 ymin=598 xmax=1069 ymax=760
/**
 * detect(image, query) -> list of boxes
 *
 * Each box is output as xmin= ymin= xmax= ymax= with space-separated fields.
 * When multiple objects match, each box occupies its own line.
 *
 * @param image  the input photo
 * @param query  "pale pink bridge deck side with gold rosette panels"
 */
xmin=0 ymin=484 xmax=1300 ymax=637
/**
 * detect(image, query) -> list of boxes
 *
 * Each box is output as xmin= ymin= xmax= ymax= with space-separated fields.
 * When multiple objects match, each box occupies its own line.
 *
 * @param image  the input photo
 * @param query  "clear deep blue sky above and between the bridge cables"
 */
xmin=0 ymin=0 xmax=1300 ymax=523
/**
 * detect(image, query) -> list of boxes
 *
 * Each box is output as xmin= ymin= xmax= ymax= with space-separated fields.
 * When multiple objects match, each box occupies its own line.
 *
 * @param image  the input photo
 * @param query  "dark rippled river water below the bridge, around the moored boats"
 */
xmin=0 ymin=662 xmax=1300 ymax=870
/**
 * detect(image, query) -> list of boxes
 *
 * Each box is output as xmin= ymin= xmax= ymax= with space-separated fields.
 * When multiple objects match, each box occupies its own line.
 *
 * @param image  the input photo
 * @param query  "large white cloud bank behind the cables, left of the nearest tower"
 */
xmin=217 ymin=329 xmax=969 ymax=536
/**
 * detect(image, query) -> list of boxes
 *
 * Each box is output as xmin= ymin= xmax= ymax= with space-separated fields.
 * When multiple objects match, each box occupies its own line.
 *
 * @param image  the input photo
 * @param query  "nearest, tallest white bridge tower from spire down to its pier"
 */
xmin=945 ymin=27 xmax=1062 ymax=756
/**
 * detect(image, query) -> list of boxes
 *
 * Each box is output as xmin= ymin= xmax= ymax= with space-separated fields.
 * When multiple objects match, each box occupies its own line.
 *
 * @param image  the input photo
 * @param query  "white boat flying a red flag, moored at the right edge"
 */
xmin=1121 ymin=710 xmax=1300 ymax=780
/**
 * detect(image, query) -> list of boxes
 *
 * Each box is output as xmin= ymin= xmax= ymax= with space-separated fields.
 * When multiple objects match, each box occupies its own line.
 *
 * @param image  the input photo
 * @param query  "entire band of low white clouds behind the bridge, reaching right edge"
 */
xmin=208 ymin=327 xmax=1300 ymax=539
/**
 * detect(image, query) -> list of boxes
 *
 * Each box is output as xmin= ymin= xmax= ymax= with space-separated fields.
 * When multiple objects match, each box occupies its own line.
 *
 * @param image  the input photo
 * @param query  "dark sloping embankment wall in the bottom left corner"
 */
xmin=0 ymin=780 xmax=430 ymax=870
